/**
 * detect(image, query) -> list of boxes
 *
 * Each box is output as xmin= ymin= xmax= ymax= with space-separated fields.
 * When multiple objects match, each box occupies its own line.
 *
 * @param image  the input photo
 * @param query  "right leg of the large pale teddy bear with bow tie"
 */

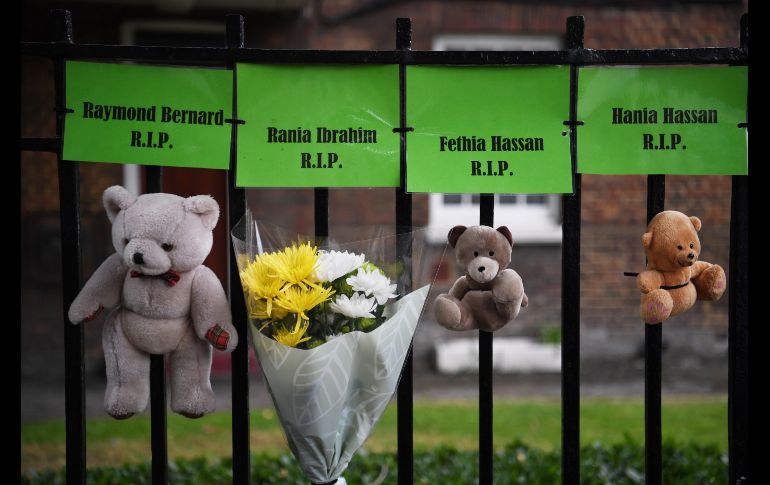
xmin=170 ymin=327 xmax=216 ymax=418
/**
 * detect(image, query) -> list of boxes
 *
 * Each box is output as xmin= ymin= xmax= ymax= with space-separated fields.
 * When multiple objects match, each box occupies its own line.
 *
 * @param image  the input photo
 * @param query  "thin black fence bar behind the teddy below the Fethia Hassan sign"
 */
xmin=479 ymin=194 xmax=495 ymax=485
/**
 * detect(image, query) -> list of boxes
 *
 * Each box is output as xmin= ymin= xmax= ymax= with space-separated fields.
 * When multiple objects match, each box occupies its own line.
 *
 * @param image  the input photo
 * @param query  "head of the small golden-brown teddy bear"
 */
xmin=642 ymin=211 xmax=701 ymax=271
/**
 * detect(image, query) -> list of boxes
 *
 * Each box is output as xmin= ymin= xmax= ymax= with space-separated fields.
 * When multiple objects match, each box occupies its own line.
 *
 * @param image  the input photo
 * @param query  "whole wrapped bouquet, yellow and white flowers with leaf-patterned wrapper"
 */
xmin=232 ymin=212 xmax=432 ymax=485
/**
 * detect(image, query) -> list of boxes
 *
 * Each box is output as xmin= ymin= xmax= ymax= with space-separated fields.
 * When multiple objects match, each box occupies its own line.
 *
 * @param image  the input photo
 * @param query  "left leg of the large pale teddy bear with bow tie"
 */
xmin=102 ymin=310 xmax=150 ymax=419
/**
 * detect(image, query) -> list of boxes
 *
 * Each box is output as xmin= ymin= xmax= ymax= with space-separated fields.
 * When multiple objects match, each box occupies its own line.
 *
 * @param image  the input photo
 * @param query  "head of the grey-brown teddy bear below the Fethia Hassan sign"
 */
xmin=447 ymin=226 xmax=513 ymax=283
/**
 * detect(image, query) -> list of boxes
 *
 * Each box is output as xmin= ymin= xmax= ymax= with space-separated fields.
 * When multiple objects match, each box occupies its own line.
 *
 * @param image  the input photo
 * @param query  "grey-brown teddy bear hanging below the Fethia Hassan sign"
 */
xmin=436 ymin=226 xmax=529 ymax=332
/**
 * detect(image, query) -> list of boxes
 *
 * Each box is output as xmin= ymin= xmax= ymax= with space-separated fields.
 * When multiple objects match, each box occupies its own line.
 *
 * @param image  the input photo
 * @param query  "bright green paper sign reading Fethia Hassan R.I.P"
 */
xmin=407 ymin=66 xmax=572 ymax=194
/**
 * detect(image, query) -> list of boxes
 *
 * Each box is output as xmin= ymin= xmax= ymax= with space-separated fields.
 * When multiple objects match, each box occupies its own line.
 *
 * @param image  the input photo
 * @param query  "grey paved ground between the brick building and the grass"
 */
xmin=21 ymin=282 xmax=727 ymax=421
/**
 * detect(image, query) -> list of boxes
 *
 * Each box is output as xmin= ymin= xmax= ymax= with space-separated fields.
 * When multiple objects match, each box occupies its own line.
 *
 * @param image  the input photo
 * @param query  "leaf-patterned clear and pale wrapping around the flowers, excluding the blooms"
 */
xmin=232 ymin=212 xmax=432 ymax=485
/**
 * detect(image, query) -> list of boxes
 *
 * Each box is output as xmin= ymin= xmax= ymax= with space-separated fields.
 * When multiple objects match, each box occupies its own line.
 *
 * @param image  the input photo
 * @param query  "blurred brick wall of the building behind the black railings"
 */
xmin=20 ymin=0 xmax=747 ymax=375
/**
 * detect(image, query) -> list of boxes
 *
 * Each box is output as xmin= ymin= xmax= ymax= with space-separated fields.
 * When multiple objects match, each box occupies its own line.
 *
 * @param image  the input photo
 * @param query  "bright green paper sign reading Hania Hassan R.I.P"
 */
xmin=578 ymin=67 xmax=748 ymax=175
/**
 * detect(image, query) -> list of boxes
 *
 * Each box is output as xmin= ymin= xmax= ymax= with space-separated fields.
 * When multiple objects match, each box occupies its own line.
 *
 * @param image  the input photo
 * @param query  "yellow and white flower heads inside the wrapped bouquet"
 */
xmin=240 ymin=242 xmax=396 ymax=349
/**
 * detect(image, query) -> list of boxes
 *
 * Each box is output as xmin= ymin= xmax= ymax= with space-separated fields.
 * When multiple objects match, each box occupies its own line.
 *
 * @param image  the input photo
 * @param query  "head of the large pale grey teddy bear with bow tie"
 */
xmin=102 ymin=185 xmax=219 ymax=275
